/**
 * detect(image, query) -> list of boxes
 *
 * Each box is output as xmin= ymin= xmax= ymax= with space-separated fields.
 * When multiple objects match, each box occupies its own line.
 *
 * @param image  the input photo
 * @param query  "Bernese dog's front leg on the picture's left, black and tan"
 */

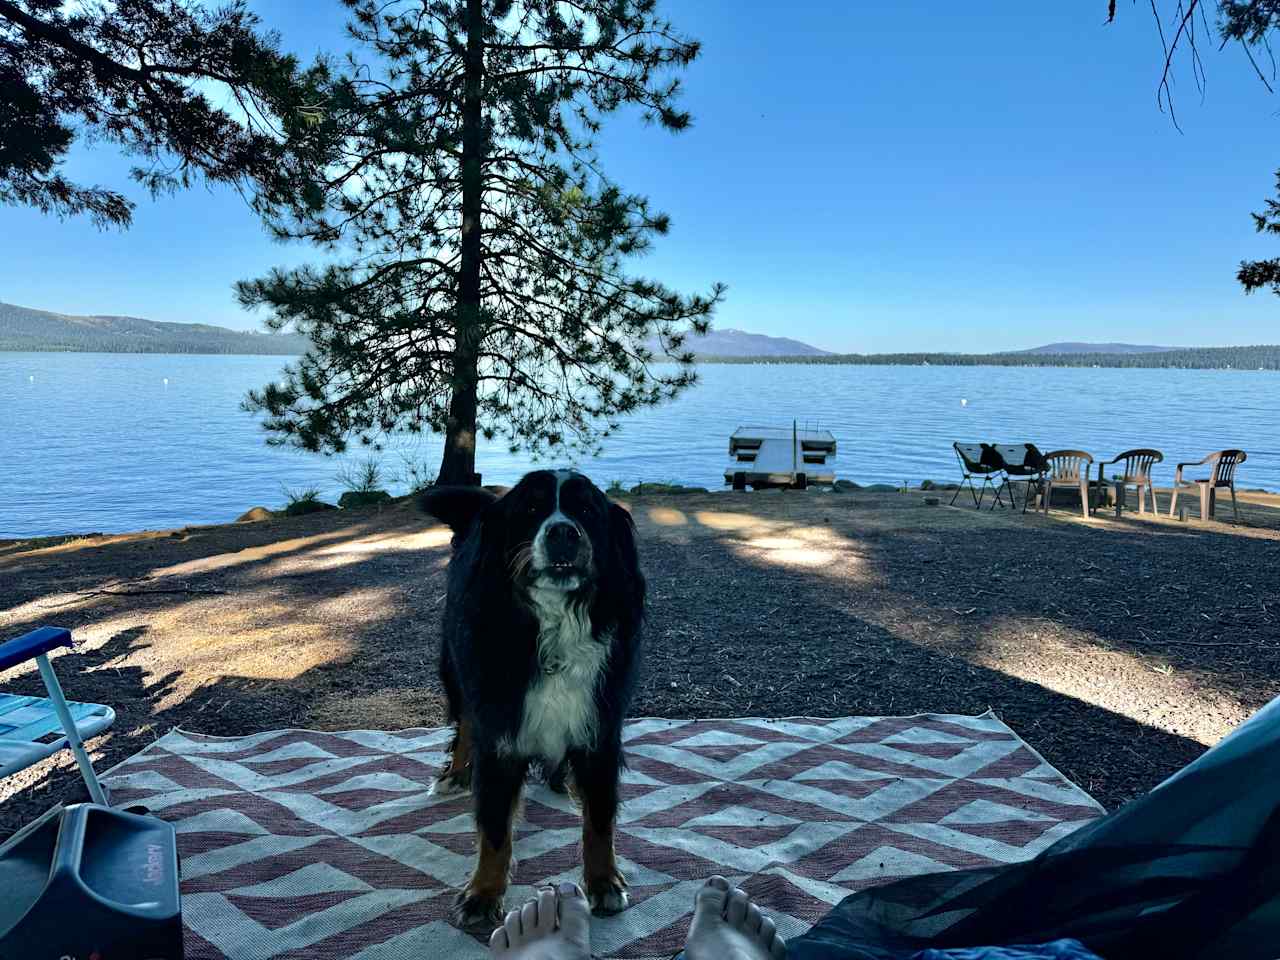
xmin=453 ymin=755 xmax=529 ymax=931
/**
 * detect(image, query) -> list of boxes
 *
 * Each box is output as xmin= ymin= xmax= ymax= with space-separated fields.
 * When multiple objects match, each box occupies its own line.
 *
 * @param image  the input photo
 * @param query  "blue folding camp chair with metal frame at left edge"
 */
xmin=0 ymin=627 xmax=115 ymax=806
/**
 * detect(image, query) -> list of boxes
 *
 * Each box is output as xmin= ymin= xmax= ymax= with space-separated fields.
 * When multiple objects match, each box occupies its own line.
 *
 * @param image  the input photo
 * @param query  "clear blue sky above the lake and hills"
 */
xmin=0 ymin=0 xmax=1280 ymax=352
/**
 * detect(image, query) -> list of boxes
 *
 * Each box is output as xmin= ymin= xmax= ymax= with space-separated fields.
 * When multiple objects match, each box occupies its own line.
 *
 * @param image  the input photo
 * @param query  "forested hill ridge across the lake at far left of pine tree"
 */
xmin=0 ymin=303 xmax=310 ymax=356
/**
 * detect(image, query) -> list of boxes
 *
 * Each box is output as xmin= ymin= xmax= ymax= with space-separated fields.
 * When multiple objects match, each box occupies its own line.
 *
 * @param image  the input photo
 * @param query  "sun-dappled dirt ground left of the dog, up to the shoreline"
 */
xmin=0 ymin=506 xmax=448 ymax=836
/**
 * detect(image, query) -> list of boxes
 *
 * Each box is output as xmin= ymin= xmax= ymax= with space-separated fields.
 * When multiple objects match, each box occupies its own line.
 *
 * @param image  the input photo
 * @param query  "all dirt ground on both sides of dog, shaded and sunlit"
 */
xmin=0 ymin=483 xmax=1280 ymax=836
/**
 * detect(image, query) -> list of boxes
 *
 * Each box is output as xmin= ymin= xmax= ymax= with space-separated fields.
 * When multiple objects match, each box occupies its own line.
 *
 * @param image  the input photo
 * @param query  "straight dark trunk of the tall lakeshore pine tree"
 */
xmin=439 ymin=0 xmax=484 ymax=484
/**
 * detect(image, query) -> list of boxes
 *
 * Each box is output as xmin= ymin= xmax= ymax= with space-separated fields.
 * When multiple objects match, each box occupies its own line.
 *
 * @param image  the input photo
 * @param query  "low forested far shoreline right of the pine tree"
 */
xmin=698 ymin=344 xmax=1280 ymax=370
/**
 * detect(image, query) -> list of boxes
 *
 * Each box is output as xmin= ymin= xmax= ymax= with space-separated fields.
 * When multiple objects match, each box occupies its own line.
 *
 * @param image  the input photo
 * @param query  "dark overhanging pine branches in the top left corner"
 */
xmin=0 ymin=0 xmax=311 ymax=227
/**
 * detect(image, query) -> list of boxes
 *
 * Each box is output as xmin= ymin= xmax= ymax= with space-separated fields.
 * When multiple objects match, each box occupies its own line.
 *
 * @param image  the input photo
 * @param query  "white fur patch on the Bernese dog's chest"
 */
xmin=515 ymin=588 xmax=609 ymax=763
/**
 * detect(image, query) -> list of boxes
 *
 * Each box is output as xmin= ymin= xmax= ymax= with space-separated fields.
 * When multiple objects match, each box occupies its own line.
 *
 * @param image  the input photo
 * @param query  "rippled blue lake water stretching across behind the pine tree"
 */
xmin=0 ymin=353 xmax=1280 ymax=539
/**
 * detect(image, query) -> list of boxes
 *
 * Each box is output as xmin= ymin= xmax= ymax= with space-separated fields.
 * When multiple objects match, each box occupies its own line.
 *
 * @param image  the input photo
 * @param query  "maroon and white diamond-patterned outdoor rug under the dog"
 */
xmin=105 ymin=714 xmax=1101 ymax=960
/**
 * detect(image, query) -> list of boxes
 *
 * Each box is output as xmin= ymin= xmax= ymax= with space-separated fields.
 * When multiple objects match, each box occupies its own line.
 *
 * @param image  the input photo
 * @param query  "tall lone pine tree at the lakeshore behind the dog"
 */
xmin=239 ymin=0 xmax=722 ymax=483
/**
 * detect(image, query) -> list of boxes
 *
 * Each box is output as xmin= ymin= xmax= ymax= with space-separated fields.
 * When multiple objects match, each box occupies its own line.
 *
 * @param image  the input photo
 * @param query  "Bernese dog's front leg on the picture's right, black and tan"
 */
xmin=570 ymin=745 xmax=627 ymax=914
